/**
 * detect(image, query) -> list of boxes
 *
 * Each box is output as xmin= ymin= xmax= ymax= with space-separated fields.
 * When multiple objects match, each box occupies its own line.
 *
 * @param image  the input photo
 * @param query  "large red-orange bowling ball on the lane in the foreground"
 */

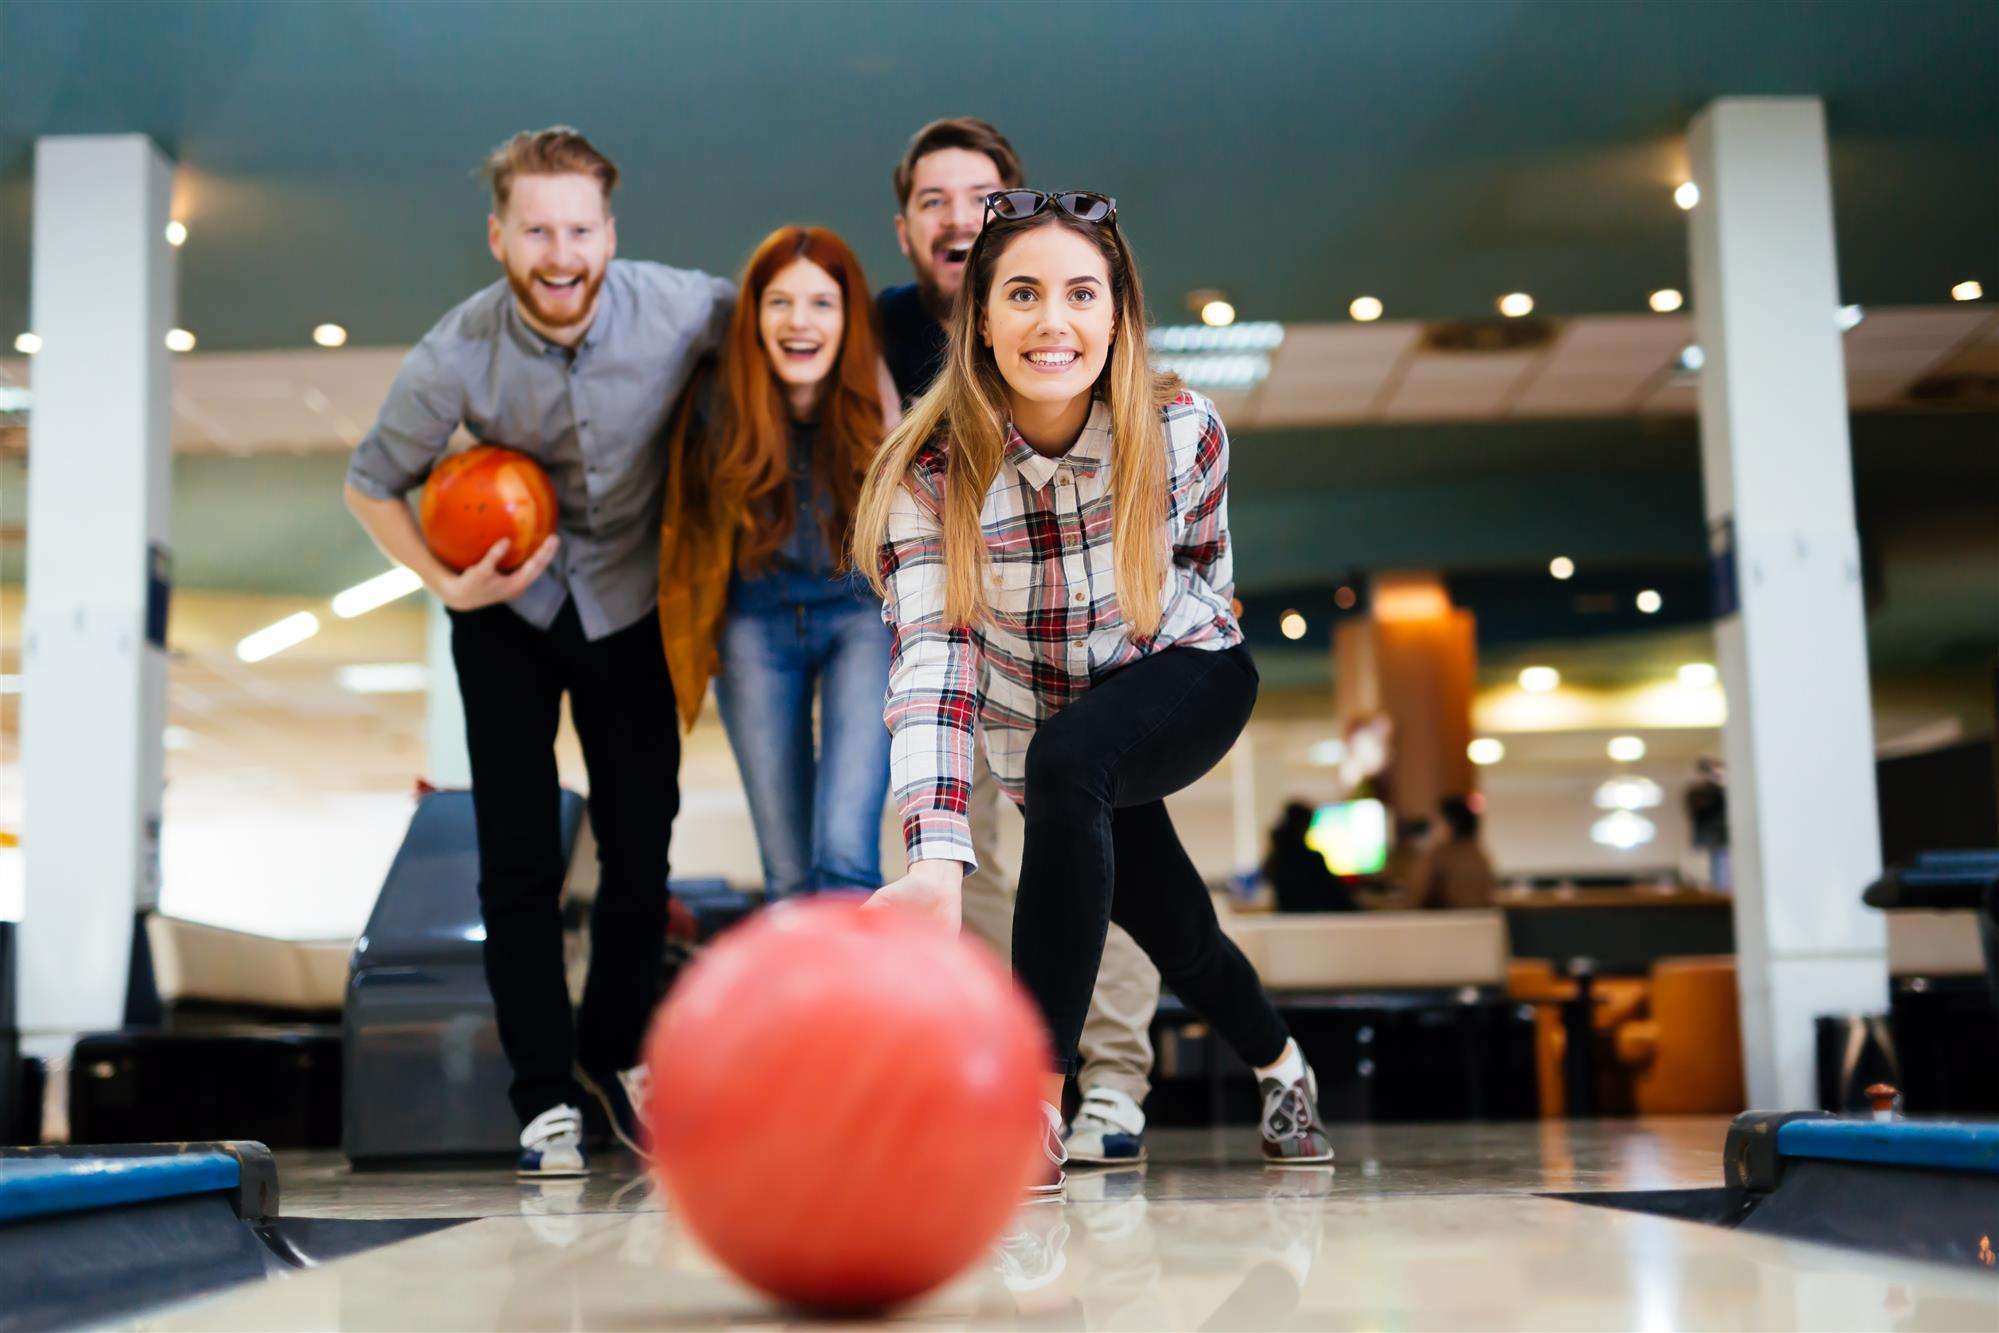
xmin=646 ymin=899 xmax=1049 ymax=1311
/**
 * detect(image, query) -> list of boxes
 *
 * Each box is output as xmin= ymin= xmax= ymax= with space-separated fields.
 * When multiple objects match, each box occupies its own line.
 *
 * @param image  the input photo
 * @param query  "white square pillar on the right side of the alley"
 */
xmin=1689 ymin=98 xmax=1887 ymax=1109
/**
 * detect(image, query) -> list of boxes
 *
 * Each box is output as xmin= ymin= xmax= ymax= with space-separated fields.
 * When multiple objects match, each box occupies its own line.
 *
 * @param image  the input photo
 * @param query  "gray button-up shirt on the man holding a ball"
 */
xmin=348 ymin=260 xmax=736 ymax=640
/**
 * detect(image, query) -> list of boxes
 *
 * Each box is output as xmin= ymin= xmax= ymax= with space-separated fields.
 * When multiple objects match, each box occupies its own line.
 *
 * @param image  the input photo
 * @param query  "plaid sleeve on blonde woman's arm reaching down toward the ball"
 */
xmin=880 ymin=469 xmax=980 ymax=865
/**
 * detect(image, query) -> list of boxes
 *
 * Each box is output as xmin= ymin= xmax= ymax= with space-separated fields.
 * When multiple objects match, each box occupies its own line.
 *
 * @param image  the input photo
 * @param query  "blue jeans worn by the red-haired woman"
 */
xmin=716 ymin=598 xmax=890 ymax=899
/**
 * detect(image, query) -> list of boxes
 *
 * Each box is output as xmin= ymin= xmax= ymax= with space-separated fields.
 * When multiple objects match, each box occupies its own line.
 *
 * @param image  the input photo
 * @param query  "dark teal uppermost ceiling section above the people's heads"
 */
xmin=0 ymin=0 xmax=1999 ymax=350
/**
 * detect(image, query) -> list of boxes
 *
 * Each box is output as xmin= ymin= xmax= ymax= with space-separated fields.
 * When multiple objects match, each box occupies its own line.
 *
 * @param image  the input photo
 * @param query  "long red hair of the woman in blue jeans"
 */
xmin=699 ymin=226 xmax=884 ymax=572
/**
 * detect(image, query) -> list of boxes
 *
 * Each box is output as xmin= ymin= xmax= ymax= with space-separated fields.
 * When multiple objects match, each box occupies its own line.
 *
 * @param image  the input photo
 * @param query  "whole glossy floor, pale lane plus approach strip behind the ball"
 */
xmin=124 ymin=1119 xmax=1999 ymax=1331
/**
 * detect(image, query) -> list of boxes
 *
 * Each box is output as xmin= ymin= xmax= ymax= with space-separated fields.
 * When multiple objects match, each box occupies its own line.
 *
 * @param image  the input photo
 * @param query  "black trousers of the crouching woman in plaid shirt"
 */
xmin=1013 ymin=648 xmax=1289 ymax=1073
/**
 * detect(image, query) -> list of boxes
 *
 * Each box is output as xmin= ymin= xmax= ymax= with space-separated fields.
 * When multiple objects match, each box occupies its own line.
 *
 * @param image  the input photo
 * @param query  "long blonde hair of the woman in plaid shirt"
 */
xmin=854 ymin=208 xmax=1179 ymax=638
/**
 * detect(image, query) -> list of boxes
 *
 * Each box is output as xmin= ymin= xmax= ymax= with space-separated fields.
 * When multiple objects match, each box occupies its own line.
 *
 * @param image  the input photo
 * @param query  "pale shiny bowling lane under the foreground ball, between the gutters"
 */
xmin=130 ymin=1167 xmax=1999 ymax=1329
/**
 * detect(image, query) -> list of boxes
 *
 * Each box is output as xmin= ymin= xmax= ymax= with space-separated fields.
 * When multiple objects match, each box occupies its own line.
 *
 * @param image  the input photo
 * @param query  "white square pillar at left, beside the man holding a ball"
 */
xmin=20 ymin=134 xmax=174 ymax=1049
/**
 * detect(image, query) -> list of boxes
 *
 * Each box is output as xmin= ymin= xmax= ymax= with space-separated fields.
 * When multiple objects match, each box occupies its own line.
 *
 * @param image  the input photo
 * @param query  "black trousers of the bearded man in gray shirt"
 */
xmin=452 ymin=602 xmax=680 ymax=1125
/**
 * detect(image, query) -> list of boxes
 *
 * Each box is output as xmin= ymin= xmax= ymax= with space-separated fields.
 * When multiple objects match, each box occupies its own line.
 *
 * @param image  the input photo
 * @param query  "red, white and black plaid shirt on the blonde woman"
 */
xmin=882 ymin=392 xmax=1243 ymax=865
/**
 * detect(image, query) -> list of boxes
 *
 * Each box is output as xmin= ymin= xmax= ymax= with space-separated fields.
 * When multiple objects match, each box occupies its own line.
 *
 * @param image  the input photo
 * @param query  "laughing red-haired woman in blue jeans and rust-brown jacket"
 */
xmin=660 ymin=226 xmax=890 ymax=899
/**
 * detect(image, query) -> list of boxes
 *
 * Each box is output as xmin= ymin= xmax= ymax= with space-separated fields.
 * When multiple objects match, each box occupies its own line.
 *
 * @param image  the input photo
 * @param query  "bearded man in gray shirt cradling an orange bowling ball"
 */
xmin=346 ymin=126 xmax=734 ymax=1175
